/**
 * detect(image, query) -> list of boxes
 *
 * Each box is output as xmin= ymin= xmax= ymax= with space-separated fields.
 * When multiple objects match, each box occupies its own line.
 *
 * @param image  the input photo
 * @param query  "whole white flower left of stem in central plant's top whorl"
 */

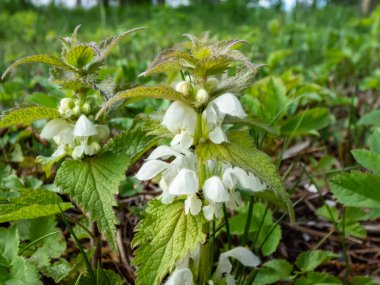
xmin=162 ymin=101 xmax=197 ymax=149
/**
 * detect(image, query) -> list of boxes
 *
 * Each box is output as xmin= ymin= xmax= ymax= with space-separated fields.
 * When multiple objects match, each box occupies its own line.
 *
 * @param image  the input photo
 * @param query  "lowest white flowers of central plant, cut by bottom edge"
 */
xmin=165 ymin=246 xmax=261 ymax=285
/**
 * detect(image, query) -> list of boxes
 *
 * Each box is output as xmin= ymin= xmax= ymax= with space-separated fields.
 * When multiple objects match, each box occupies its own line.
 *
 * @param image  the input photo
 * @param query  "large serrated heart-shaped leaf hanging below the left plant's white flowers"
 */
xmin=55 ymin=152 xmax=129 ymax=251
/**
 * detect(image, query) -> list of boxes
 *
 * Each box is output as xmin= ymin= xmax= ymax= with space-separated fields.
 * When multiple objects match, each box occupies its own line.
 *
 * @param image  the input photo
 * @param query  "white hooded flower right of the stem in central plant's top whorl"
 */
xmin=202 ymin=93 xmax=247 ymax=144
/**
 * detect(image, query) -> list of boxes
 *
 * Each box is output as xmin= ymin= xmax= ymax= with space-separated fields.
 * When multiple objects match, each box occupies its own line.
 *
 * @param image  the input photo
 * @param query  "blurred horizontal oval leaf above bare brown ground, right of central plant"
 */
xmin=281 ymin=108 xmax=329 ymax=136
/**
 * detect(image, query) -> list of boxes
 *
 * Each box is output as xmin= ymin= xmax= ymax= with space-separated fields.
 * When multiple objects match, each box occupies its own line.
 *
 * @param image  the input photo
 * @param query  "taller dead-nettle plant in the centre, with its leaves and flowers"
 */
xmin=99 ymin=35 xmax=293 ymax=284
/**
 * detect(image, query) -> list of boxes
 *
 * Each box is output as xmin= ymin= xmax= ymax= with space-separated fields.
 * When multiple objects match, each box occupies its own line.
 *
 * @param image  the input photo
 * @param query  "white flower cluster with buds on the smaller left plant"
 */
xmin=41 ymin=98 xmax=109 ymax=159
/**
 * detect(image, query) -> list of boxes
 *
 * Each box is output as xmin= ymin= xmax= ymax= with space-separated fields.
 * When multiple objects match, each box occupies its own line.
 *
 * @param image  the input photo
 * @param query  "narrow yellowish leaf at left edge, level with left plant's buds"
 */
xmin=0 ymin=106 xmax=59 ymax=128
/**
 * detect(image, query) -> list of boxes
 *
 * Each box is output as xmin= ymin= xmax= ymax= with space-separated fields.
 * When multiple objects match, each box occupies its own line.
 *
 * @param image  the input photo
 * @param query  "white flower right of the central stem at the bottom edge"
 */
xmin=214 ymin=246 xmax=260 ymax=285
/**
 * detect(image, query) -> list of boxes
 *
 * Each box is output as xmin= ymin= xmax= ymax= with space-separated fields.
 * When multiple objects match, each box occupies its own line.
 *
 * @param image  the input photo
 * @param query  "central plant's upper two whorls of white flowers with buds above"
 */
xmin=136 ymin=81 xmax=266 ymax=220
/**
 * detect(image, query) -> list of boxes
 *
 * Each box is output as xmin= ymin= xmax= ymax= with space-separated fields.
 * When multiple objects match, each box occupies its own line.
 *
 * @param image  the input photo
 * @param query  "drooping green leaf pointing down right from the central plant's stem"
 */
xmin=196 ymin=132 xmax=294 ymax=220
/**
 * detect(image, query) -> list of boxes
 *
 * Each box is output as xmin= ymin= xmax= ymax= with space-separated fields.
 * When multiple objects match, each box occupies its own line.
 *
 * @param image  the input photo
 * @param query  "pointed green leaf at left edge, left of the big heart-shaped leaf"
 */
xmin=0 ymin=189 xmax=72 ymax=223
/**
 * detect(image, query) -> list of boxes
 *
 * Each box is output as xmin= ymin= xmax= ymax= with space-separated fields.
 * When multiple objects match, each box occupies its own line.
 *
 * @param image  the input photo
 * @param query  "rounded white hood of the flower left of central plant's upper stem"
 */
xmin=162 ymin=101 xmax=197 ymax=135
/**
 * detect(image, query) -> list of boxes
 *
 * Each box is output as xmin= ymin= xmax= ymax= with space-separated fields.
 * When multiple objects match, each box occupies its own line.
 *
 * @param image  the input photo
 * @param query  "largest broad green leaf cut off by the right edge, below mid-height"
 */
xmin=330 ymin=171 xmax=380 ymax=208
